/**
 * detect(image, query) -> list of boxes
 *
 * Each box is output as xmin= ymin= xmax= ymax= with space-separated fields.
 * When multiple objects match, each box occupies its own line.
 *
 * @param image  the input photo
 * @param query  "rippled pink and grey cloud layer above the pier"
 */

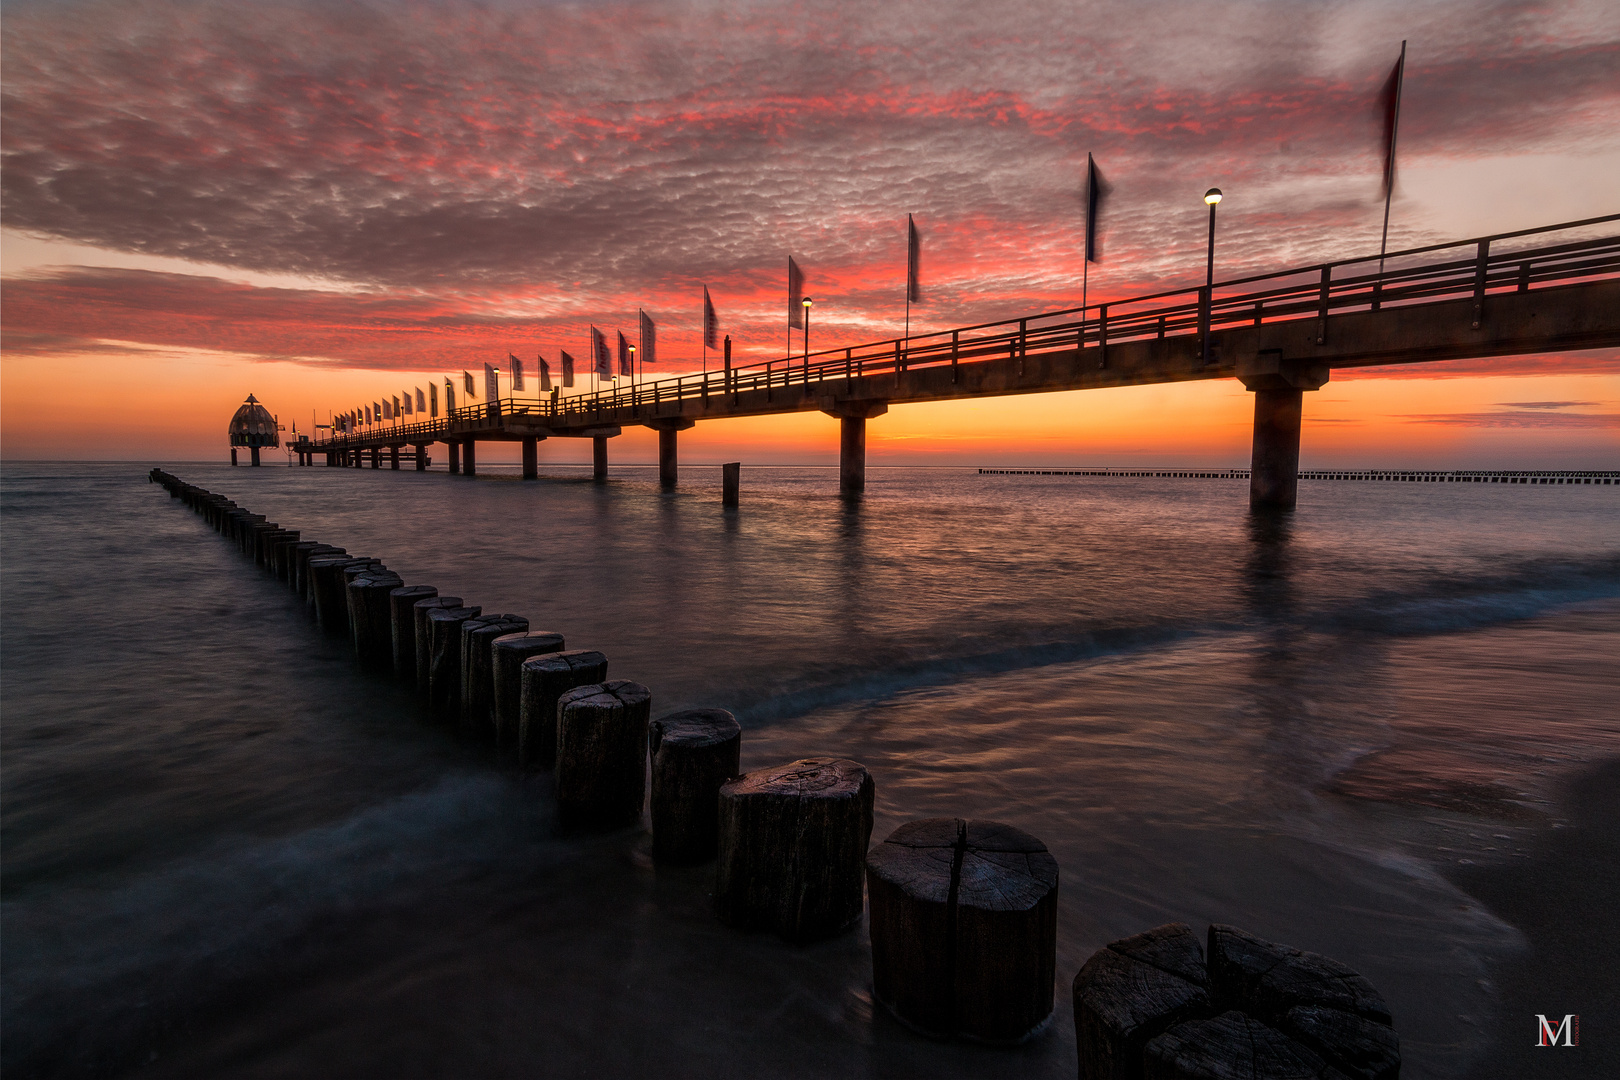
xmin=3 ymin=0 xmax=1620 ymax=374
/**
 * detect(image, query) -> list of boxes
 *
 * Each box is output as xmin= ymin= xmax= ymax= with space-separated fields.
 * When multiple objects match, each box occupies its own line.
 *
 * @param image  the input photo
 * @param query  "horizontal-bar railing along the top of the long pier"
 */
xmin=309 ymin=214 xmax=1620 ymax=447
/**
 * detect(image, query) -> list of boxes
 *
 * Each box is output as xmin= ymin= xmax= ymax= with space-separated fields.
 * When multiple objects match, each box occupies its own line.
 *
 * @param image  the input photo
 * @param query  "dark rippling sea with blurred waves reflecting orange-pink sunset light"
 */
xmin=0 ymin=463 xmax=1620 ymax=1078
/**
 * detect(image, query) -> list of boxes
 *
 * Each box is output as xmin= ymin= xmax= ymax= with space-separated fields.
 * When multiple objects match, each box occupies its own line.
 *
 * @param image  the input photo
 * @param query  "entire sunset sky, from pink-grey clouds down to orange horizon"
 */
xmin=0 ymin=0 xmax=1620 ymax=468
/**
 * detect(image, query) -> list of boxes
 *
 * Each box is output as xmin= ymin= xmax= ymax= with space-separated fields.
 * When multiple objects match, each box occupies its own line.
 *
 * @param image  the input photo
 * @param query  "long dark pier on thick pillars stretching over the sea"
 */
xmin=298 ymin=214 xmax=1620 ymax=508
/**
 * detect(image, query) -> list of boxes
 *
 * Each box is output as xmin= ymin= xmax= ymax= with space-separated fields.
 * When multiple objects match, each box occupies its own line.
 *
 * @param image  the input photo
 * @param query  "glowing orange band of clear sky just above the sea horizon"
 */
xmin=0 ymin=341 xmax=1620 ymax=468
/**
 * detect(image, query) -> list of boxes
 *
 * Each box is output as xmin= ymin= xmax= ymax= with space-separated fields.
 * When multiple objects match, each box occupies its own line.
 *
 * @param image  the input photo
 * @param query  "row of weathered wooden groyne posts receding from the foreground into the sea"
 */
xmin=149 ymin=468 xmax=1400 ymax=1080
